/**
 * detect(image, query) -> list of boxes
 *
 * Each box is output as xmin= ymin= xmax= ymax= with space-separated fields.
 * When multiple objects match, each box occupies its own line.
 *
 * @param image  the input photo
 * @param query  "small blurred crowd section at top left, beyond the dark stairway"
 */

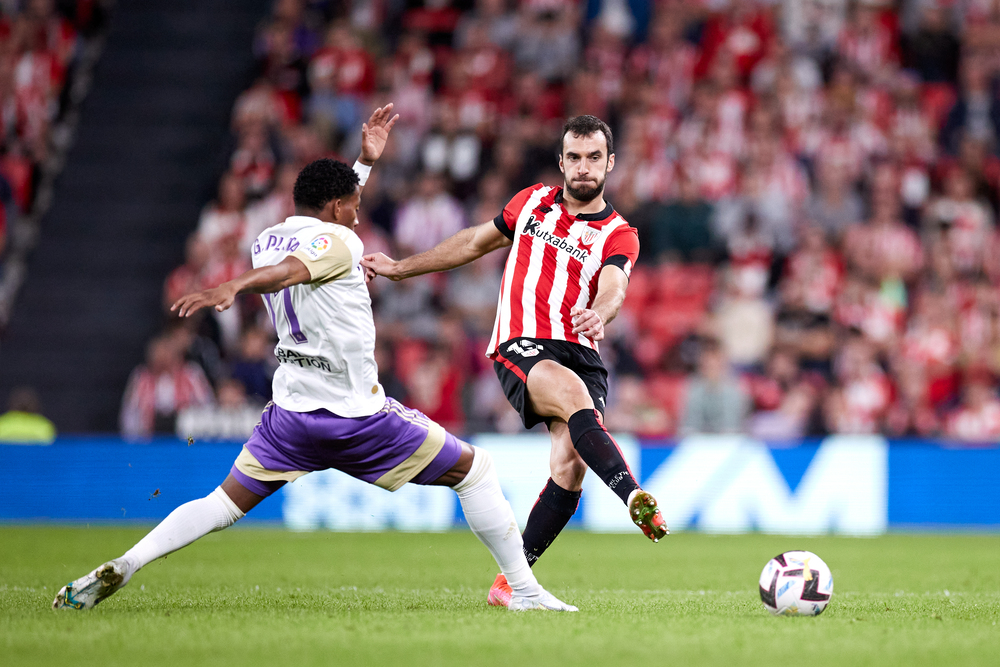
xmin=0 ymin=0 xmax=100 ymax=277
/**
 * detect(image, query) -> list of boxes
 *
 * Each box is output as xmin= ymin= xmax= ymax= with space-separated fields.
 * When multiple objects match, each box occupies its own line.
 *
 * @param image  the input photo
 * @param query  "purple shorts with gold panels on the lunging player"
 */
xmin=230 ymin=398 xmax=462 ymax=496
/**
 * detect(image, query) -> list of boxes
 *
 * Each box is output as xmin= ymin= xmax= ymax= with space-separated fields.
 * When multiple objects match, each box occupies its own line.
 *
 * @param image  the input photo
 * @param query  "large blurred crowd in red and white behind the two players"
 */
xmin=121 ymin=0 xmax=1000 ymax=442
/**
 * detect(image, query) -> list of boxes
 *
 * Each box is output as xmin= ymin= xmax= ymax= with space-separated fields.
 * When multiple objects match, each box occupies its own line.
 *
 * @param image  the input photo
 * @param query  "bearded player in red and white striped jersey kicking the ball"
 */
xmin=361 ymin=116 xmax=668 ymax=606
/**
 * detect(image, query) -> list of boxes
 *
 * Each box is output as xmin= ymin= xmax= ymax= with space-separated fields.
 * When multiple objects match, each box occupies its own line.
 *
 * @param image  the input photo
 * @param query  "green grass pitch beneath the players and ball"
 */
xmin=0 ymin=527 xmax=1000 ymax=667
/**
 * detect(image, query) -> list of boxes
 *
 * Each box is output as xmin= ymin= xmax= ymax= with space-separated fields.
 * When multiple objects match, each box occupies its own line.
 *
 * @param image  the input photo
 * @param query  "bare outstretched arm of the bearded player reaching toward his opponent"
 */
xmin=361 ymin=221 xmax=511 ymax=280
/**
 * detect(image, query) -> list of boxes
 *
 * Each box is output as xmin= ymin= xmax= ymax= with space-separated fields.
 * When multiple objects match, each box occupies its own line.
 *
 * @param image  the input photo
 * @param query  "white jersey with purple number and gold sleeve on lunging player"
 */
xmin=253 ymin=215 xmax=385 ymax=417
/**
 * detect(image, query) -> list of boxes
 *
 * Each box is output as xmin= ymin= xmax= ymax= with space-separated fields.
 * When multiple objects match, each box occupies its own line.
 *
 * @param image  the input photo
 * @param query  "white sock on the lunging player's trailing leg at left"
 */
xmin=121 ymin=487 xmax=244 ymax=582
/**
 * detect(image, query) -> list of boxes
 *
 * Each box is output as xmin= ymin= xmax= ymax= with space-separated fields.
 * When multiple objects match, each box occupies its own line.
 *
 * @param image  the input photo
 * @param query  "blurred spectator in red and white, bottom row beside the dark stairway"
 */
xmin=120 ymin=336 xmax=215 ymax=438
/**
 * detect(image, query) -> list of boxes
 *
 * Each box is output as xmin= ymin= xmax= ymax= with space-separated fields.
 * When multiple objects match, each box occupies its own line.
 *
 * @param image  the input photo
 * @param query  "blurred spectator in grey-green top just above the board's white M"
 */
xmin=680 ymin=340 xmax=750 ymax=435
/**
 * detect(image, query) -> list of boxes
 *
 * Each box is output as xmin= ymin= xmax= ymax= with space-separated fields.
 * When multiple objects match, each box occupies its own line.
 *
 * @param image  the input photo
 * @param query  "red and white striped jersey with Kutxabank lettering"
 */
xmin=486 ymin=183 xmax=639 ymax=357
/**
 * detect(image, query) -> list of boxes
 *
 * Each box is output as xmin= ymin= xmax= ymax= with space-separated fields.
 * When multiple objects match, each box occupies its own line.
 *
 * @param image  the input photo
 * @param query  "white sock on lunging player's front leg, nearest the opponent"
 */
xmin=452 ymin=447 xmax=542 ymax=595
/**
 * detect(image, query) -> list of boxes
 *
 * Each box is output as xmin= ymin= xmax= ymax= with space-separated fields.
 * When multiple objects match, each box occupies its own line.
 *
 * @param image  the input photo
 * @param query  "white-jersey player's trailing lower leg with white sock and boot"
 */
xmin=52 ymin=475 xmax=264 ymax=610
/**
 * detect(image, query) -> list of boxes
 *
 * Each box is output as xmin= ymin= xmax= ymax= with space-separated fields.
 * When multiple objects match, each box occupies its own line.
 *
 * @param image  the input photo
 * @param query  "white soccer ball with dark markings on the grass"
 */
xmin=760 ymin=551 xmax=833 ymax=616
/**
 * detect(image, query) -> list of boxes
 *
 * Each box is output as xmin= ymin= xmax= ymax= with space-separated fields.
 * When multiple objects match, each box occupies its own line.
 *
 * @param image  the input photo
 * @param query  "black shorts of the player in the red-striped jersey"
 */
xmin=493 ymin=338 xmax=608 ymax=428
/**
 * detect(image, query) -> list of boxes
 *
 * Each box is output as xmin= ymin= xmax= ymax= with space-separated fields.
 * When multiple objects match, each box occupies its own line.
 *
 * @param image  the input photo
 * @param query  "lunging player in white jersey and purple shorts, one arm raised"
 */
xmin=52 ymin=104 xmax=576 ymax=611
